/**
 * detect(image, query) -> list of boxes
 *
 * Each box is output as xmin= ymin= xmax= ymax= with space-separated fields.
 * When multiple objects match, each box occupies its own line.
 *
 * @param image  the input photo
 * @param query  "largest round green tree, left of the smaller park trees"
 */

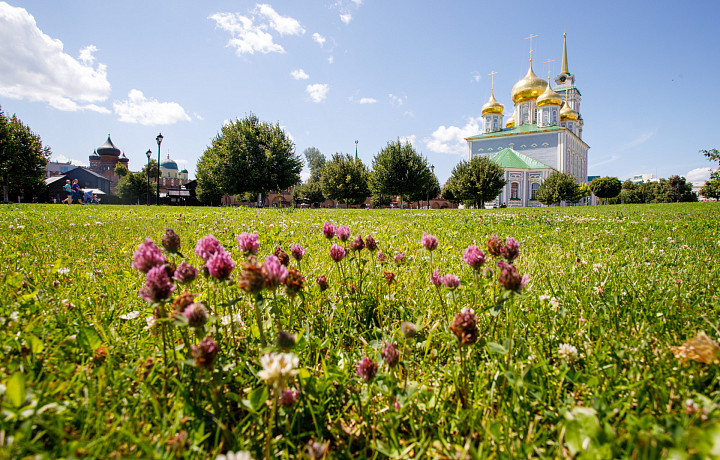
xmin=196 ymin=114 xmax=302 ymax=202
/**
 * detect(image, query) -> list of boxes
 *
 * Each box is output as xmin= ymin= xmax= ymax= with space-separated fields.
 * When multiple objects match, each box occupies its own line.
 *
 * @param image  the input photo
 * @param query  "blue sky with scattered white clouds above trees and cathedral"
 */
xmin=0 ymin=0 xmax=720 ymax=186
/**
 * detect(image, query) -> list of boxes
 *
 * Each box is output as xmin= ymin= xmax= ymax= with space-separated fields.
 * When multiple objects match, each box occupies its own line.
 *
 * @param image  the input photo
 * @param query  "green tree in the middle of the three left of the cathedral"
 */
xmin=370 ymin=139 xmax=439 ymax=208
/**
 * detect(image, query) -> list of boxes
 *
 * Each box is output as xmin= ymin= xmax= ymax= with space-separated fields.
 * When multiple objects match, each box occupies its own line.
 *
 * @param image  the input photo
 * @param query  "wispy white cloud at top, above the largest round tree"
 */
xmin=208 ymin=4 xmax=305 ymax=55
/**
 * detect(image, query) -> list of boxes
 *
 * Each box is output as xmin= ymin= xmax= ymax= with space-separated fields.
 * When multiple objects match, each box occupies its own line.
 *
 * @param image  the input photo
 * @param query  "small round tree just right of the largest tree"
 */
xmin=320 ymin=153 xmax=370 ymax=206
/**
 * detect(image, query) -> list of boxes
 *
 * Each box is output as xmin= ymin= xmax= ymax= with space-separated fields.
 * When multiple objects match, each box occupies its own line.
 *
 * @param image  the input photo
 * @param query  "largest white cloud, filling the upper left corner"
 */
xmin=0 ymin=2 xmax=110 ymax=113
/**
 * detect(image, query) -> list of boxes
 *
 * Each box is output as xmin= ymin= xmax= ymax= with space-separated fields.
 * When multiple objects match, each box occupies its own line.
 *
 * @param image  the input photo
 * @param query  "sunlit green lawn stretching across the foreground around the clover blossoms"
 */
xmin=0 ymin=203 xmax=720 ymax=458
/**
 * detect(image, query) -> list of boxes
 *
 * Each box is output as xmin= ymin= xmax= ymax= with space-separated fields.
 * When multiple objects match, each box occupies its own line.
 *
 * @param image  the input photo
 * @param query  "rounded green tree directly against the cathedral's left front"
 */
xmin=442 ymin=156 xmax=507 ymax=208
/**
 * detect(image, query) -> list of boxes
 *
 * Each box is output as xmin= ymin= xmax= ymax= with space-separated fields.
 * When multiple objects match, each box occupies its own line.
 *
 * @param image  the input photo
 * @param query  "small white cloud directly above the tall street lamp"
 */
xmin=113 ymin=89 xmax=190 ymax=126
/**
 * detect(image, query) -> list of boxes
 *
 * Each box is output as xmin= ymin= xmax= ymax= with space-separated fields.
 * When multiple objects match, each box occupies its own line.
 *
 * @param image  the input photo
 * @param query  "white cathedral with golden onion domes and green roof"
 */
xmin=465 ymin=34 xmax=590 ymax=207
